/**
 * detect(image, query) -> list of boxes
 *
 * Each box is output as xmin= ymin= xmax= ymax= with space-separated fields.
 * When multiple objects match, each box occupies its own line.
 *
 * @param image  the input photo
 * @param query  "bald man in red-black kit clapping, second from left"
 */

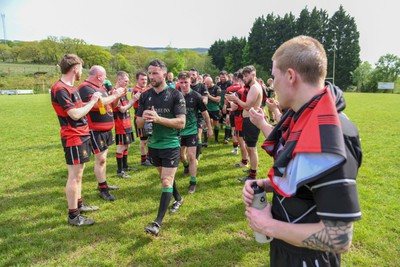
xmin=78 ymin=65 xmax=125 ymax=201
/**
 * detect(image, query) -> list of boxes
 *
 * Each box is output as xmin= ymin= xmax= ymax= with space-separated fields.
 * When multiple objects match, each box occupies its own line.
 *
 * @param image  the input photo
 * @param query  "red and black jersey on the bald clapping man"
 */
xmin=78 ymin=81 xmax=114 ymax=132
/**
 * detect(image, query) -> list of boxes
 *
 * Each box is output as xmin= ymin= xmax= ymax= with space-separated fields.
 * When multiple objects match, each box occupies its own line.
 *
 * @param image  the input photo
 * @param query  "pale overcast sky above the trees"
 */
xmin=0 ymin=0 xmax=400 ymax=65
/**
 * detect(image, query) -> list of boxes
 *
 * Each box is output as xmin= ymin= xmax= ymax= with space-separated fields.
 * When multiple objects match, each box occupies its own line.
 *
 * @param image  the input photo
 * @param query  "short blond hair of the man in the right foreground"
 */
xmin=272 ymin=35 xmax=328 ymax=84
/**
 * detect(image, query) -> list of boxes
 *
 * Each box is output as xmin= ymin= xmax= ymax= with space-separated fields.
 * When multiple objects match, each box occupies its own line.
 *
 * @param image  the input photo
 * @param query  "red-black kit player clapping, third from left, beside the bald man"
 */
xmin=111 ymin=71 xmax=138 ymax=178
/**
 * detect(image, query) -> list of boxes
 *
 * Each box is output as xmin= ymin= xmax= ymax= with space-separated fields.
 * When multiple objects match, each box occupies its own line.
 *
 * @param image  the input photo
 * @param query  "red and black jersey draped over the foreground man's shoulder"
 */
xmin=261 ymin=86 xmax=346 ymax=197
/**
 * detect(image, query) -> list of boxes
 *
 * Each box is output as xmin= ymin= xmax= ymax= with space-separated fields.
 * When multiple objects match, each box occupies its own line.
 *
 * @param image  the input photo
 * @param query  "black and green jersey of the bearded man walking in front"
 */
xmin=137 ymin=86 xmax=186 ymax=149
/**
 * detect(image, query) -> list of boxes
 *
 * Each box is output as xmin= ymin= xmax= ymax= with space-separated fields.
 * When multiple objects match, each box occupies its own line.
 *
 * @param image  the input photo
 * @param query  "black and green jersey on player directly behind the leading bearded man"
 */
xmin=180 ymin=89 xmax=207 ymax=136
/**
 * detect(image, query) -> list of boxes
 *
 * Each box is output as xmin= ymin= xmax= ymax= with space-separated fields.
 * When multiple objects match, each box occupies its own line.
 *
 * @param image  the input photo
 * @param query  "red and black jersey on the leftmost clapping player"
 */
xmin=51 ymin=80 xmax=89 ymax=147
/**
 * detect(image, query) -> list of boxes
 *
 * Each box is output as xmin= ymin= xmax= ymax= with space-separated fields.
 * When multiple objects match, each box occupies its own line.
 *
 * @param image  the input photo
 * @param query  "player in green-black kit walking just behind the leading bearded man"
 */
xmin=178 ymin=71 xmax=212 ymax=194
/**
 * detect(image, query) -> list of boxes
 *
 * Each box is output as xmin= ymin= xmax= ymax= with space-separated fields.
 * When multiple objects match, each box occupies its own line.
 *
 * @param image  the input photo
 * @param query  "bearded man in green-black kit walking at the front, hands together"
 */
xmin=136 ymin=59 xmax=186 ymax=235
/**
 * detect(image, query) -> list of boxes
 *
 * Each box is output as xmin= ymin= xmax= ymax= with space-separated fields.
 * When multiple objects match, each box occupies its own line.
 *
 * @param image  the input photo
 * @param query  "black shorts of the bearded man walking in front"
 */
xmin=149 ymin=147 xmax=181 ymax=168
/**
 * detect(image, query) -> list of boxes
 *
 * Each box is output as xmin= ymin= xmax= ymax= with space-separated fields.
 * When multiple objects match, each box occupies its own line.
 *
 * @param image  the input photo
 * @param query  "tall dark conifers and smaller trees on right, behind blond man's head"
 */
xmin=208 ymin=6 xmax=400 ymax=92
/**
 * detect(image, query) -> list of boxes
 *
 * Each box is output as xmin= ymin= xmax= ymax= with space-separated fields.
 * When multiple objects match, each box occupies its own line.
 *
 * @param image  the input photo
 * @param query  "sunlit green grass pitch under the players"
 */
xmin=0 ymin=94 xmax=400 ymax=266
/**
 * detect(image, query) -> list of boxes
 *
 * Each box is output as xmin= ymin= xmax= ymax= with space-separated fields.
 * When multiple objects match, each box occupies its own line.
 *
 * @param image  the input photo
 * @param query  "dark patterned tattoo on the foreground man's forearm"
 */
xmin=302 ymin=220 xmax=353 ymax=253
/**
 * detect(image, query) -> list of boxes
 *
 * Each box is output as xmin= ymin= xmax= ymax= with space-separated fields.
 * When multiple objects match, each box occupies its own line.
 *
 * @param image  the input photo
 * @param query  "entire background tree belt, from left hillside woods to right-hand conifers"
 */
xmin=0 ymin=3 xmax=400 ymax=92
